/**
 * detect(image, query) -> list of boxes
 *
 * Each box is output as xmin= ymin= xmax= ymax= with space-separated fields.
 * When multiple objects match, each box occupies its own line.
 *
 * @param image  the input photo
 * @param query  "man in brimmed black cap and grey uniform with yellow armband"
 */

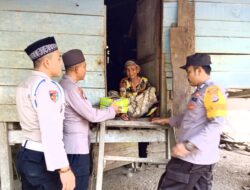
xmin=152 ymin=53 xmax=226 ymax=190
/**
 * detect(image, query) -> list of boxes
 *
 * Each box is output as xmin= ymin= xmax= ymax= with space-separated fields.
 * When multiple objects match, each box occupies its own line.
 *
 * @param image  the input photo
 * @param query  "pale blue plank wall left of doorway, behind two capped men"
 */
xmin=0 ymin=0 xmax=106 ymax=122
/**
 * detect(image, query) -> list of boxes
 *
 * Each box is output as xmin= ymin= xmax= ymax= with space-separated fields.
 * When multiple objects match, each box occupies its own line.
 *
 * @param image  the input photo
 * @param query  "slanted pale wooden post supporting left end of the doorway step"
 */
xmin=96 ymin=122 xmax=106 ymax=190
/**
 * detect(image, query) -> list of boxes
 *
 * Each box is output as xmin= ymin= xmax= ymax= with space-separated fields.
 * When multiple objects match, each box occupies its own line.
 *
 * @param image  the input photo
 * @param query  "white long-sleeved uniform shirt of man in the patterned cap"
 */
xmin=16 ymin=71 xmax=69 ymax=171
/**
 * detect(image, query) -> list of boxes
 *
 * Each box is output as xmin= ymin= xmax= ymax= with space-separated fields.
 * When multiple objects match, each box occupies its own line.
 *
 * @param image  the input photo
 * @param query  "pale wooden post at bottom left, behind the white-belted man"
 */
xmin=0 ymin=122 xmax=14 ymax=190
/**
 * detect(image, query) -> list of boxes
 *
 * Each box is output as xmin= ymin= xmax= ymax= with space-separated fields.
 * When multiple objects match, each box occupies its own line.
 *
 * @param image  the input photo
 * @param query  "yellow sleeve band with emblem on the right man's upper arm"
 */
xmin=204 ymin=86 xmax=227 ymax=118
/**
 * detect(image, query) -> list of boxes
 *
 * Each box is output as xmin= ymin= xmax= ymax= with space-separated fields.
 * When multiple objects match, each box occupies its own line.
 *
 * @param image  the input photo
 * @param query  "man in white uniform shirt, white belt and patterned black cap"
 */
xmin=16 ymin=37 xmax=75 ymax=190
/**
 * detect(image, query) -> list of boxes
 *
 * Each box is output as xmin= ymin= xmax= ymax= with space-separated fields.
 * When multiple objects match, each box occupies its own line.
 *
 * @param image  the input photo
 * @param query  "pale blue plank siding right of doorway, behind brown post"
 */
xmin=163 ymin=0 xmax=250 ymax=90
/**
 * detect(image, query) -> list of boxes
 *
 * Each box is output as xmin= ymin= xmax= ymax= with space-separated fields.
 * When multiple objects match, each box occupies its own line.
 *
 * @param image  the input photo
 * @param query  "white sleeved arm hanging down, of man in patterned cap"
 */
xmin=36 ymin=82 xmax=69 ymax=171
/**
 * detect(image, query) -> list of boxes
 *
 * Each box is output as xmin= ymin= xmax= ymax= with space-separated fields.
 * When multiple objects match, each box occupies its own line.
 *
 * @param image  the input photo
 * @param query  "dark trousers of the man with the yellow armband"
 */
xmin=158 ymin=158 xmax=214 ymax=190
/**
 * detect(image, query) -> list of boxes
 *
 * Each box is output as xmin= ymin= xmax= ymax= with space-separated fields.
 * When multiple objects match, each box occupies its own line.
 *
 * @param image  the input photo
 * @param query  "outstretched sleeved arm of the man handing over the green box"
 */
xmin=67 ymin=88 xmax=116 ymax=122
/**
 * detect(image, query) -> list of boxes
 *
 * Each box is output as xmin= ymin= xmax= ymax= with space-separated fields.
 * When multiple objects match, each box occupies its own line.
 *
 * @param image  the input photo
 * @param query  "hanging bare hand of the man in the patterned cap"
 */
xmin=60 ymin=170 xmax=76 ymax=190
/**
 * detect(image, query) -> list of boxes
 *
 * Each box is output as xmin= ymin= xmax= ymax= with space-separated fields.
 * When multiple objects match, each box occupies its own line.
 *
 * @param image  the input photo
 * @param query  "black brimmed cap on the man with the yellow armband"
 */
xmin=180 ymin=53 xmax=212 ymax=70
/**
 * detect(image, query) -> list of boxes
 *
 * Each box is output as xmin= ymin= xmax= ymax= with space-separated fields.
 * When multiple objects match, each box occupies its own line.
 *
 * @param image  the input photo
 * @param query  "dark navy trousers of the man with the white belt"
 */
xmin=16 ymin=147 xmax=62 ymax=190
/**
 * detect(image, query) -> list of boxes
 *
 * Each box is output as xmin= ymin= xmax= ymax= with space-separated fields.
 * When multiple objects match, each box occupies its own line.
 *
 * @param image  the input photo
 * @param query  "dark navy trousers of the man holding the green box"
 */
xmin=68 ymin=154 xmax=90 ymax=190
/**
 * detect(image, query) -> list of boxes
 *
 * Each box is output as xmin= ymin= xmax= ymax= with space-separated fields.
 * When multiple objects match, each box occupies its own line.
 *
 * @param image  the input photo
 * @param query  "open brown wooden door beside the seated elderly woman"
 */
xmin=136 ymin=0 xmax=162 ymax=94
